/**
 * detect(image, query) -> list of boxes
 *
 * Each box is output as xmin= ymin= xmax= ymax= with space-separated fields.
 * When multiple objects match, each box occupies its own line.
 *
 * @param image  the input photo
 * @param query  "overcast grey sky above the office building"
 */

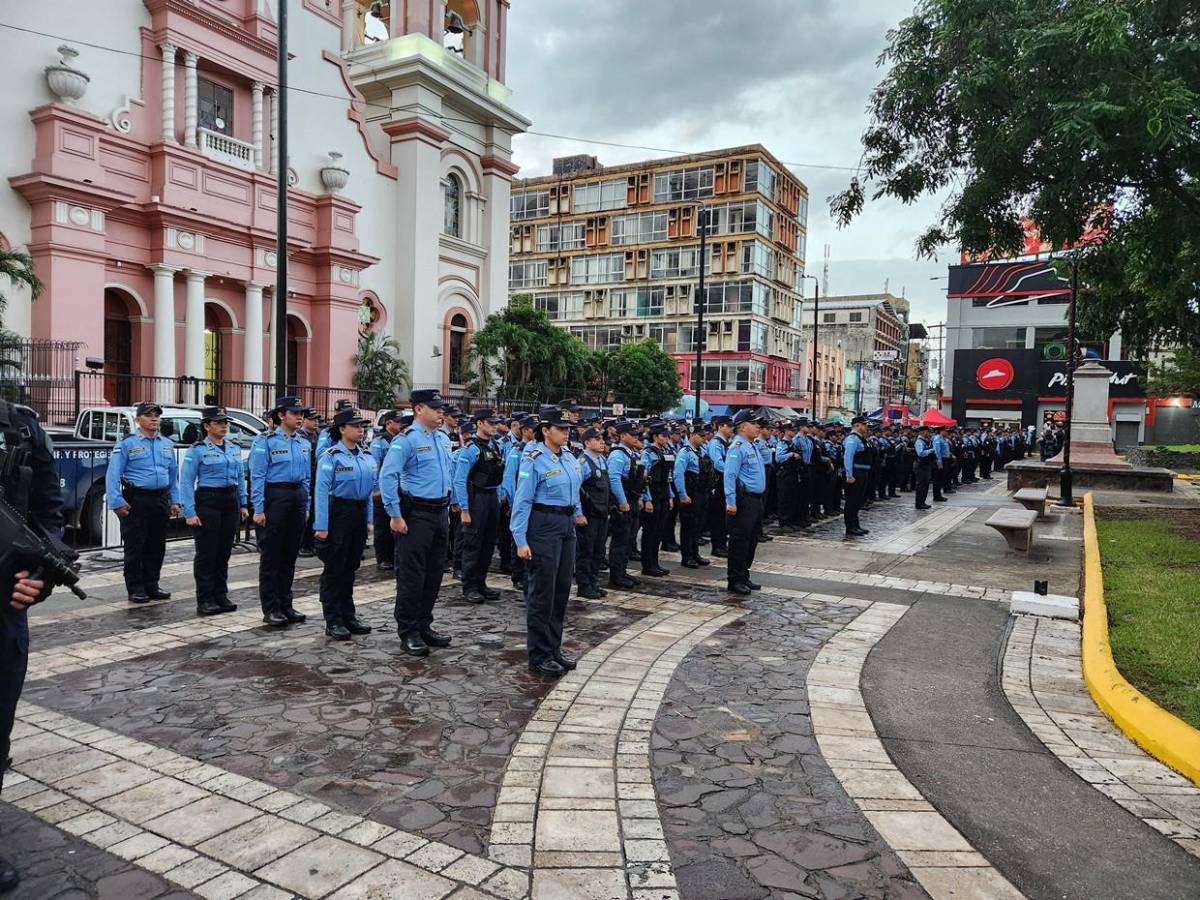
xmin=506 ymin=0 xmax=949 ymax=323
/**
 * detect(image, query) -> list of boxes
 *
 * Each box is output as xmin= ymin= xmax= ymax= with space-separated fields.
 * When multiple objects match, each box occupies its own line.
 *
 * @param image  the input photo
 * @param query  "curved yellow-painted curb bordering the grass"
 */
xmin=1082 ymin=491 xmax=1200 ymax=785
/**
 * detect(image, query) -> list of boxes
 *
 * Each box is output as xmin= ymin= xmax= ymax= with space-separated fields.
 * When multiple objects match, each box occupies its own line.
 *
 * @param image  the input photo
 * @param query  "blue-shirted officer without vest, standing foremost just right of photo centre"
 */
xmin=724 ymin=409 xmax=767 ymax=596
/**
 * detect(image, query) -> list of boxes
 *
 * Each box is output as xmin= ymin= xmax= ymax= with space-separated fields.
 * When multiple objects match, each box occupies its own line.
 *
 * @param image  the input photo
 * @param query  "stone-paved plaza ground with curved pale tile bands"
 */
xmin=0 ymin=484 xmax=1192 ymax=900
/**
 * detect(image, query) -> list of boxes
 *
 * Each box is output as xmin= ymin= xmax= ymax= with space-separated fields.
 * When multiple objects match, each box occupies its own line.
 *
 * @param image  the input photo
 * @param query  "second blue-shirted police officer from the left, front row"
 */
xmin=179 ymin=407 xmax=250 ymax=616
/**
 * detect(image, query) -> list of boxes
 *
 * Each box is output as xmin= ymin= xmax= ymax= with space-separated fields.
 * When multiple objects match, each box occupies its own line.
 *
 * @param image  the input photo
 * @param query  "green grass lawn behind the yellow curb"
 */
xmin=1096 ymin=509 xmax=1200 ymax=728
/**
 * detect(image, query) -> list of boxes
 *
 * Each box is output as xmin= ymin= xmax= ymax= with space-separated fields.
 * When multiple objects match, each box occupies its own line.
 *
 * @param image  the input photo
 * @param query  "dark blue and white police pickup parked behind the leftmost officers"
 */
xmin=47 ymin=406 xmax=264 ymax=544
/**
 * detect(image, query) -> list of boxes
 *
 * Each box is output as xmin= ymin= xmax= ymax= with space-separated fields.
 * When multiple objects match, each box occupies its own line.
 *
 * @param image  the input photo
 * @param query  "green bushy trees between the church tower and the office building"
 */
xmin=468 ymin=294 xmax=593 ymax=396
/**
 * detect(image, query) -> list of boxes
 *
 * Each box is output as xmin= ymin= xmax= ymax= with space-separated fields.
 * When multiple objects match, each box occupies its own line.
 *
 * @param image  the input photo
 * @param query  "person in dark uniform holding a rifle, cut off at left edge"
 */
xmin=0 ymin=401 xmax=62 ymax=893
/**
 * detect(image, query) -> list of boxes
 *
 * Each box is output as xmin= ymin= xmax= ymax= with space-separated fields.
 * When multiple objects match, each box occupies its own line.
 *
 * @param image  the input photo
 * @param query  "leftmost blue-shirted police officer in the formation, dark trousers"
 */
xmin=104 ymin=402 xmax=179 ymax=604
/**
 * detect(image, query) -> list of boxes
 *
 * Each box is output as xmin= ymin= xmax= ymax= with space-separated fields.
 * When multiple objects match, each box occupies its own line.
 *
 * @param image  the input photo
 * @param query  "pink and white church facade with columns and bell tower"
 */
xmin=0 ymin=0 xmax=523 ymax=412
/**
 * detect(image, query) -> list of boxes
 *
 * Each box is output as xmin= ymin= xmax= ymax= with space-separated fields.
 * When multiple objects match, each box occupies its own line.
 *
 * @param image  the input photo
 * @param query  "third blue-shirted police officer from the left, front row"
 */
xmin=250 ymin=397 xmax=313 ymax=628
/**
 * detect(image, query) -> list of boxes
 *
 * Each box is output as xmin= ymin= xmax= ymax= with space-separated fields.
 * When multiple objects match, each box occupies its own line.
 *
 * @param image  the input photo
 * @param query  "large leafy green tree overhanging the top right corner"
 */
xmin=830 ymin=0 xmax=1200 ymax=353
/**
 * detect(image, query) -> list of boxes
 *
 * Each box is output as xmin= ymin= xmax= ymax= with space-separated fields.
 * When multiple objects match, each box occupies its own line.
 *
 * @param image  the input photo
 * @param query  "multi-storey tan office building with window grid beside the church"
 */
xmin=509 ymin=144 xmax=808 ymax=408
